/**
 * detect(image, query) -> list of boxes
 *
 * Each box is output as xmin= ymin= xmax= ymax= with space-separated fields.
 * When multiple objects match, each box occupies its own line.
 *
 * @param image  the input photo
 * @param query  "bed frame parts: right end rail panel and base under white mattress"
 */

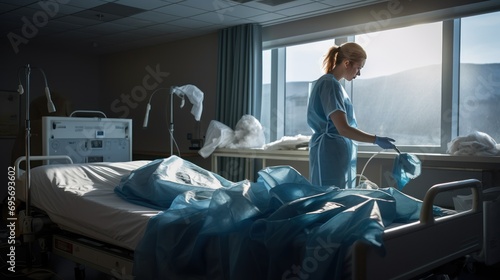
xmin=14 ymin=156 xmax=483 ymax=280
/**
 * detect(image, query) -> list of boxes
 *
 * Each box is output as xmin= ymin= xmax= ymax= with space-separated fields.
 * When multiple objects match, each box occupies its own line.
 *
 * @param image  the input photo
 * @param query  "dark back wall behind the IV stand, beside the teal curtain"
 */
xmin=100 ymin=33 xmax=218 ymax=169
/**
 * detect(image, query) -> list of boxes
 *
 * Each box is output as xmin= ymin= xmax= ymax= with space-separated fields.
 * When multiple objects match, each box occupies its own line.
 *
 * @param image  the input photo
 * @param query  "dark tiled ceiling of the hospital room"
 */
xmin=0 ymin=0 xmax=383 ymax=54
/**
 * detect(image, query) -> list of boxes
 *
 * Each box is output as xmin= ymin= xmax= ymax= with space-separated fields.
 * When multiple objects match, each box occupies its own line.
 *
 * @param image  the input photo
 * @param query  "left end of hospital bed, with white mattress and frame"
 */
xmin=16 ymin=159 xmax=154 ymax=279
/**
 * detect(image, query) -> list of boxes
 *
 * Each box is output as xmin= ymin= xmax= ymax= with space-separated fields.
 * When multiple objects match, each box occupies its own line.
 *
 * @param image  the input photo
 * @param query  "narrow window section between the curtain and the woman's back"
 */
xmin=261 ymin=40 xmax=334 ymax=141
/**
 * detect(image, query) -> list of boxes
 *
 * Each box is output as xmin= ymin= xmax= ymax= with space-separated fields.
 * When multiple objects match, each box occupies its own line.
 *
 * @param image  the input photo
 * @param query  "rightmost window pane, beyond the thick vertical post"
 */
xmin=458 ymin=12 xmax=500 ymax=142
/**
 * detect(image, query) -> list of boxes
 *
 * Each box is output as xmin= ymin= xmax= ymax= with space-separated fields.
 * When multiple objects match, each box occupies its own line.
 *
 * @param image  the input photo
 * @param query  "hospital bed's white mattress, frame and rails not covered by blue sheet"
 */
xmin=13 ymin=154 xmax=494 ymax=279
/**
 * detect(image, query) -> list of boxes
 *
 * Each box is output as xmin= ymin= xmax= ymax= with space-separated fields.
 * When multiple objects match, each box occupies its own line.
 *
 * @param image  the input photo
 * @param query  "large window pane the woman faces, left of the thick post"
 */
xmin=352 ymin=22 xmax=442 ymax=146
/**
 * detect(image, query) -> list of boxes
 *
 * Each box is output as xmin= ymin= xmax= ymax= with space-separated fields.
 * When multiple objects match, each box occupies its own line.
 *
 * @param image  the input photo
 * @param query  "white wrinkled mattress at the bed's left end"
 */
xmin=20 ymin=161 xmax=159 ymax=250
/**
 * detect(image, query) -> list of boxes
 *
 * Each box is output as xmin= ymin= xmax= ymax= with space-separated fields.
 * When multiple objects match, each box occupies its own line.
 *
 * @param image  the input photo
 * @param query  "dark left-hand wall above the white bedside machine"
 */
xmin=0 ymin=44 xmax=100 ymax=200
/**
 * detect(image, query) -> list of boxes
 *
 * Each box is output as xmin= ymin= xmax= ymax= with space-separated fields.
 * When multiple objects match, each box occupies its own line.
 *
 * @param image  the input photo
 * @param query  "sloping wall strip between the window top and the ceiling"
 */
xmin=262 ymin=0 xmax=500 ymax=48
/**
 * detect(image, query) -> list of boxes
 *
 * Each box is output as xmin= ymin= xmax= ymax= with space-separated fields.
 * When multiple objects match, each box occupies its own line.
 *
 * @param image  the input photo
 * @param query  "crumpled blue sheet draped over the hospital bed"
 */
xmin=115 ymin=156 xmax=445 ymax=280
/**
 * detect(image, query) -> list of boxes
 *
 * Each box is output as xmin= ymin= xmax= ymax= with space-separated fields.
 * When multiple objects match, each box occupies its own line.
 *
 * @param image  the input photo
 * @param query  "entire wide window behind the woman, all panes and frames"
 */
xmin=261 ymin=13 xmax=500 ymax=153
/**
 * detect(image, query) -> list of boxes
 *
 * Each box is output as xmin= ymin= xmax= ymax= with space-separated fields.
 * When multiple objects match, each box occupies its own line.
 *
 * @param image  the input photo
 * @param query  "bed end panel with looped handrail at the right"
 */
xmin=351 ymin=179 xmax=483 ymax=280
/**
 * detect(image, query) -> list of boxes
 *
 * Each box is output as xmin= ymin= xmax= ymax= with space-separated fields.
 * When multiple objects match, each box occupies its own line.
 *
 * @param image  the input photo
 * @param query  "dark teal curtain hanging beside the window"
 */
xmin=216 ymin=24 xmax=262 ymax=181
